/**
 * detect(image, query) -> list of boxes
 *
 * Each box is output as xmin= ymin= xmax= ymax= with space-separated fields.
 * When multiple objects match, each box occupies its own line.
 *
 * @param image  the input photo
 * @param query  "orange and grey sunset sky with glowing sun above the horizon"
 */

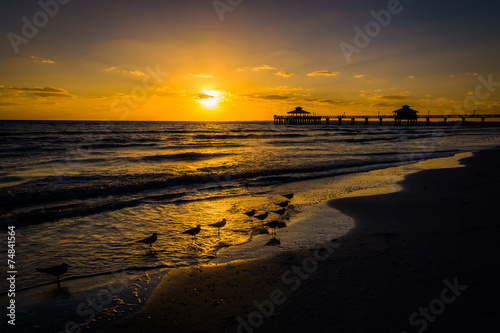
xmin=0 ymin=0 xmax=500 ymax=121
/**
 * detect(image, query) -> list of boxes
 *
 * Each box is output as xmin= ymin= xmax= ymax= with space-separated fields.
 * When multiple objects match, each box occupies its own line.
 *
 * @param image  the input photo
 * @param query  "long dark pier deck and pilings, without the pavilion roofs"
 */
xmin=274 ymin=114 xmax=500 ymax=125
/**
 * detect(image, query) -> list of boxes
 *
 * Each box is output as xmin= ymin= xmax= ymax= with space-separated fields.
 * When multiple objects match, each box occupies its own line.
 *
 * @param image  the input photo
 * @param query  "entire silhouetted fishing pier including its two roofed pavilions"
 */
xmin=274 ymin=105 xmax=500 ymax=125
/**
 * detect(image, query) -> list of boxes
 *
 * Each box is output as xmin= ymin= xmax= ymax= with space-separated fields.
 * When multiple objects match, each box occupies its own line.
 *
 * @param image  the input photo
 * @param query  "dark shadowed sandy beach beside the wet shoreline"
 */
xmin=96 ymin=149 xmax=500 ymax=332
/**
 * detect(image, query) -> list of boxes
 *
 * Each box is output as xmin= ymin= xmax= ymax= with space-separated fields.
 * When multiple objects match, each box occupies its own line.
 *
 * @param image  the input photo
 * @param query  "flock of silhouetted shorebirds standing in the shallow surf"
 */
xmin=36 ymin=193 xmax=294 ymax=287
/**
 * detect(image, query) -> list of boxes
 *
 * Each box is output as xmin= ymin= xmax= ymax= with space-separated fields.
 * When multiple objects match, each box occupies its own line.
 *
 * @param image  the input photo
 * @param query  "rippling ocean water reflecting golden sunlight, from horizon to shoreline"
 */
xmin=0 ymin=121 xmax=500 ymax=291
